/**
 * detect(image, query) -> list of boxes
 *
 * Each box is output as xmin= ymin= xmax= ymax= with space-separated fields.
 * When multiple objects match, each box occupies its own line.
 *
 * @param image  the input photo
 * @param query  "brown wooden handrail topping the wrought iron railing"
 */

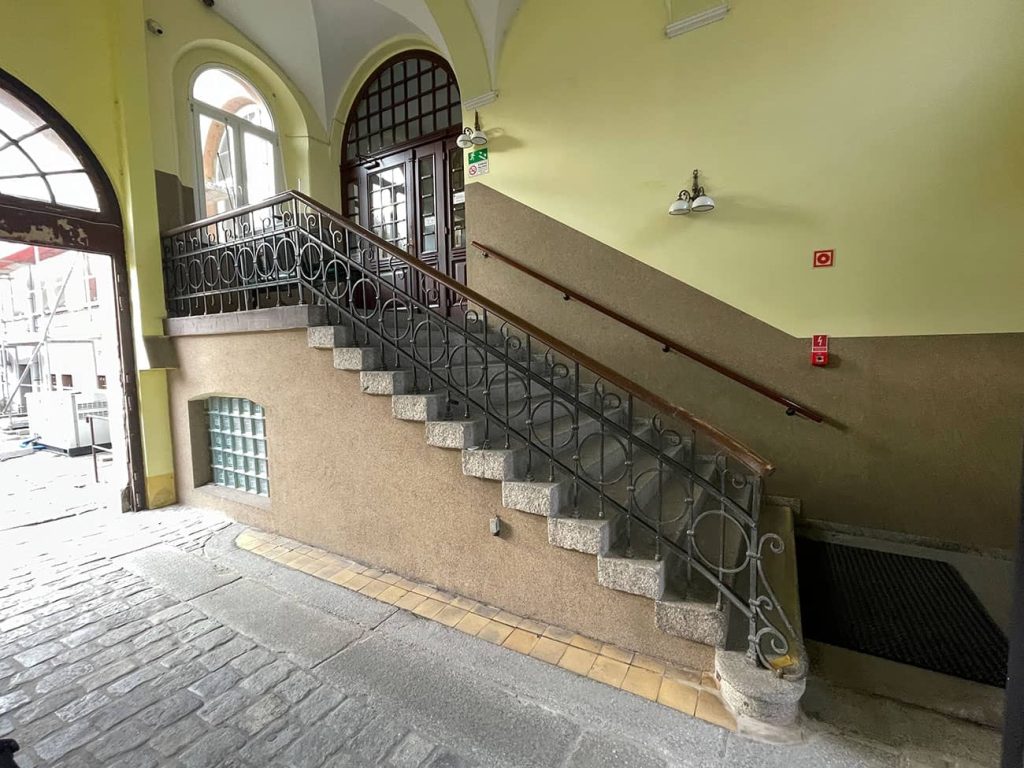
xmin=163 ymin=189 xmax=775 ymax=475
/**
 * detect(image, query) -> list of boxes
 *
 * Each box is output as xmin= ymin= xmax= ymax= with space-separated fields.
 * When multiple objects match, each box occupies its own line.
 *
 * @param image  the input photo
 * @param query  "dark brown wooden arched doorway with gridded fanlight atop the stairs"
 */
xmin=341 ymin=51 xmax=466 ymax=309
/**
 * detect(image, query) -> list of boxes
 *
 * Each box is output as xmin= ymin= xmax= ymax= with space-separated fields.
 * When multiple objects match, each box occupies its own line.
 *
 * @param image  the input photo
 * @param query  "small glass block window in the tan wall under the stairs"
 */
xmin=206 ymin=397 xmax=270 ymax=497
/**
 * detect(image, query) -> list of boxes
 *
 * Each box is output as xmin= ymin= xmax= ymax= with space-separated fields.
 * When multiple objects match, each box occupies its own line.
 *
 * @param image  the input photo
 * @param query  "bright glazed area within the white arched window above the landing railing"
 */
xmin=191 ymin=68 xmax=284 ymax=218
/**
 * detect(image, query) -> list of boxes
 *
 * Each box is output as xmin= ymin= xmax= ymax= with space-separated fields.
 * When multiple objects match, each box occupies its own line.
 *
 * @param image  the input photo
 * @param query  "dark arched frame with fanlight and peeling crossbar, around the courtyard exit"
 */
xmin=0 ymin=70 xmax=145 ymax=509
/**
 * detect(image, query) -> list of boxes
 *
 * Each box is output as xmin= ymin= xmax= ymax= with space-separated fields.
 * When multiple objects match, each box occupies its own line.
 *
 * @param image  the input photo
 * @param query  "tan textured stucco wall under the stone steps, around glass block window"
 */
xmin=170 ymin=331 xmax=712 ymax=669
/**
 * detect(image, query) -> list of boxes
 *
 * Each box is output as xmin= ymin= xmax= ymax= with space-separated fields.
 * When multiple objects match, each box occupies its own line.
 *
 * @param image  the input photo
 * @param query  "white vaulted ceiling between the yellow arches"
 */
xmin=209 ymin=0 xmax=521 ymax=129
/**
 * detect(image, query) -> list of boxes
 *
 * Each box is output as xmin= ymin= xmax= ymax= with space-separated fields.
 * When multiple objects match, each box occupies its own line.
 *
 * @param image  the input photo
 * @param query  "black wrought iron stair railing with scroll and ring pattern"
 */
xmin=157 ymin=191 xmax=803 ymax=674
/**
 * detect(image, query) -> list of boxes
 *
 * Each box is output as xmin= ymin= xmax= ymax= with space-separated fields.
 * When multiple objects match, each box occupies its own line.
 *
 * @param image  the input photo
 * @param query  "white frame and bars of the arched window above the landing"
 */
xmin=188 ymin=62 xmax=285 ymax=219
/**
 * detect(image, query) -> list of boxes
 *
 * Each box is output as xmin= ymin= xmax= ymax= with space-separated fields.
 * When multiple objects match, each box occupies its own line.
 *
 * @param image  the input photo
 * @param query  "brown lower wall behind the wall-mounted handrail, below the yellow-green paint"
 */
xmin=467 ymin=183 xmax=1024 ymax=549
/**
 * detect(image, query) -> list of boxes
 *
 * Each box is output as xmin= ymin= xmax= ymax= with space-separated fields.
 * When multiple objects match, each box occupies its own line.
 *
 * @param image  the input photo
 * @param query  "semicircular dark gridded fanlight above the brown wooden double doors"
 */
xmin=345 ymin=52 xmax=462 ymax=161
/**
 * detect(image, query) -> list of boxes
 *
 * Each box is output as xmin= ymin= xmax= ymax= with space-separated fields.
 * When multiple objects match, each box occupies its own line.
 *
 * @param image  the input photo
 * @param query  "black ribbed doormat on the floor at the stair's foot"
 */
xmin=797 ymin=539 xmax=1008 ymax=688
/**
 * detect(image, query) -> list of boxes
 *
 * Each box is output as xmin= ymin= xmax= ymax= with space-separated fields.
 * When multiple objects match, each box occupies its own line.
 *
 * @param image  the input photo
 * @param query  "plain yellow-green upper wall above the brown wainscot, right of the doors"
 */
xmin=481 ymin=0 xmax=1024 ymax=336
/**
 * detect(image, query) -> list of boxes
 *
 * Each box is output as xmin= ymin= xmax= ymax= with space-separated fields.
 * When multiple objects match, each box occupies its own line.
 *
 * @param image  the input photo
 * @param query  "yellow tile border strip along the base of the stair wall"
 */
xmin=234 ymin=528 xmax=736 ymax=731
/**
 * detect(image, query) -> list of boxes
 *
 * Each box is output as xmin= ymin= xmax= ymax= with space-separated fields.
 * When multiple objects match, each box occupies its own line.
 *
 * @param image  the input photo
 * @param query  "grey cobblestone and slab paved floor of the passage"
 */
xmin=0 ymin=495 xmax=999 ymax=768
